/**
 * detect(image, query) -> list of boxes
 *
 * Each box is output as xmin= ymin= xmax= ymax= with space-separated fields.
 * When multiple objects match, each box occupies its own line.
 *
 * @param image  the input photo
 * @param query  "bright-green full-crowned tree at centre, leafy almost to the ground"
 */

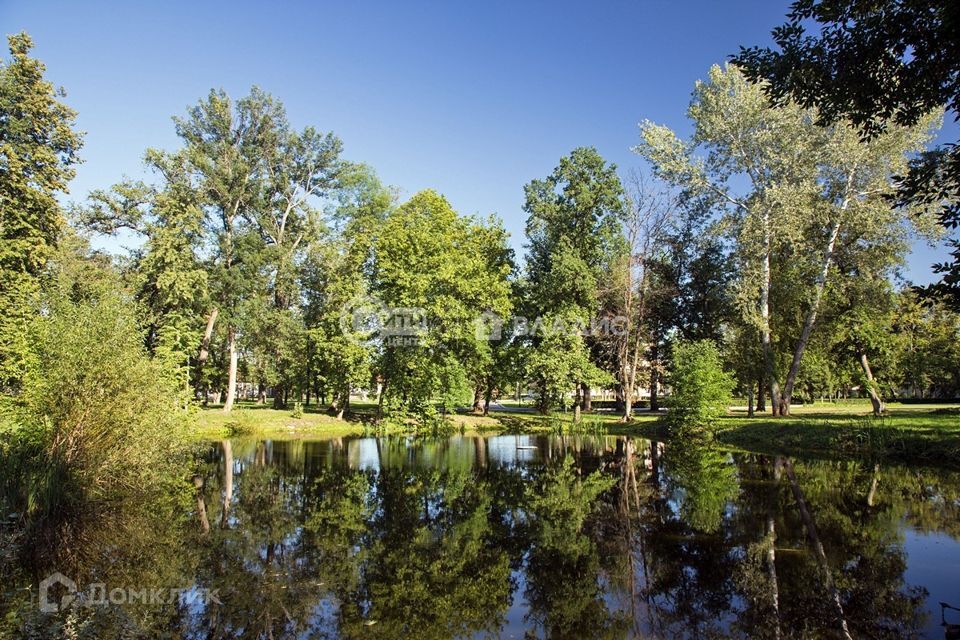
xmin=372 ymin=191 xmax=512 ymax=416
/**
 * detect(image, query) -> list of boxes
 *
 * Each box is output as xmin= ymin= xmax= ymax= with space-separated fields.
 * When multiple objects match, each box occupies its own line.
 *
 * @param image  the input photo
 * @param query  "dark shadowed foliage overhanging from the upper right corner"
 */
xmin=733 ymin=0 xmax=960 ymax=307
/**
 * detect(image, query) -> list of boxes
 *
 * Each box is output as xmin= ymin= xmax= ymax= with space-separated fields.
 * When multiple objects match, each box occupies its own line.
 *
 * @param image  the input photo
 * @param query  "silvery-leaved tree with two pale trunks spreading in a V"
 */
xmin=638 ymin=67 xmax=934 ymax=415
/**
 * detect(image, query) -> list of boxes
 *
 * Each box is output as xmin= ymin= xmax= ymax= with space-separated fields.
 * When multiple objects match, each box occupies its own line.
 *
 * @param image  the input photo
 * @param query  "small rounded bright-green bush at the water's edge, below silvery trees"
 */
xmin=665 ymin=340 xmax=735 ymax=431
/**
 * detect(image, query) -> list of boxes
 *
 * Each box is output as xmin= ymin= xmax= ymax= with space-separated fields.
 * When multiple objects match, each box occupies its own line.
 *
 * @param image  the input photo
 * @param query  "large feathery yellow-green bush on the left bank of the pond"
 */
xmin=0 ymin=293 xmax=195 ymax=515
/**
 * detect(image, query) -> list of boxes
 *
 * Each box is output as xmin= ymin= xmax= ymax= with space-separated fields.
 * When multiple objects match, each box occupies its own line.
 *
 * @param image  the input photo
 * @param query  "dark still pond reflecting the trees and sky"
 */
xmin=7 ymin=435 xmax=960 ymax=638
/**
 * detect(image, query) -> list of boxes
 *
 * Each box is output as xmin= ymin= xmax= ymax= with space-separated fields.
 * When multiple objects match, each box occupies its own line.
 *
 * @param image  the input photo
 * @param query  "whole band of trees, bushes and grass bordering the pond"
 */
xmin=0 ymin=0 xmax=960 ymax=536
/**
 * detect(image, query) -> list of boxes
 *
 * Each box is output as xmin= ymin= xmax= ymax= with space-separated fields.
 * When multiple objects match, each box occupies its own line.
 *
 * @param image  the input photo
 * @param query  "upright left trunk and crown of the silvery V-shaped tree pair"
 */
xmin=635 ymin=66 xmax=815 ymax=413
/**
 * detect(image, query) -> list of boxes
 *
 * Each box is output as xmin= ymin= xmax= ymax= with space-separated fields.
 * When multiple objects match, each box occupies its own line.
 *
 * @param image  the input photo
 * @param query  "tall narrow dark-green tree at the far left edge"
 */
xmin=0 ymin=33 xmax=82 ymax=388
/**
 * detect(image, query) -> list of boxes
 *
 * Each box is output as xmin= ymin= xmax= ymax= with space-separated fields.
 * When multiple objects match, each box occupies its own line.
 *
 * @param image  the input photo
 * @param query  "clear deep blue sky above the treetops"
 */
xmin=0 ymin=0 xmax=958 ymax=282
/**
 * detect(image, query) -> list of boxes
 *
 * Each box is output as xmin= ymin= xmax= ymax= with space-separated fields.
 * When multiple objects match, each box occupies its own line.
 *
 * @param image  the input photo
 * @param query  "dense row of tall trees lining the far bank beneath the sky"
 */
xmin=0 ymin=34 xmax=960 ymax=436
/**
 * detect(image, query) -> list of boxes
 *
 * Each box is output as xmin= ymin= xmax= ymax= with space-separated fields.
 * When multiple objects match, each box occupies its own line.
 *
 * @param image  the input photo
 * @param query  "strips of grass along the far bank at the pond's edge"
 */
xmin=196 ymin=401 xmax=960 ymax=467
